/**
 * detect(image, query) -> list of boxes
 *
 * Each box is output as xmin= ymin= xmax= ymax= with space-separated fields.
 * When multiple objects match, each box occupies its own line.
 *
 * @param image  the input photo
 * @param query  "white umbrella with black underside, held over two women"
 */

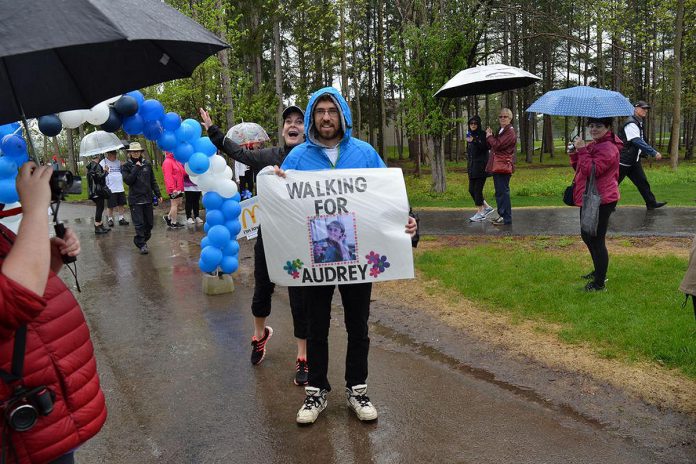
xmin=434 ymin=64 xmax=541 ymax=98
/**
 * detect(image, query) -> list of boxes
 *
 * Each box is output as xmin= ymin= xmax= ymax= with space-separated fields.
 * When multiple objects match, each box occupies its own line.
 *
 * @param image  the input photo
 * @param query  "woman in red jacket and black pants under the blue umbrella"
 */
xmin=569 ymin=118 xmax=623 ymax=292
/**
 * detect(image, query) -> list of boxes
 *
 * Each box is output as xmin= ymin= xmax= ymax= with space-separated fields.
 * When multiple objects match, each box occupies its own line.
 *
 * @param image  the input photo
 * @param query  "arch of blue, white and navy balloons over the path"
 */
xmin=0 ymin=90 xmax=241 ymax=274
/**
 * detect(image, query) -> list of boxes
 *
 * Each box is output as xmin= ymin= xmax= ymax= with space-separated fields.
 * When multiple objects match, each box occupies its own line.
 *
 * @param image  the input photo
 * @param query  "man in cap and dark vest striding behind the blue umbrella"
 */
xmin=619 ymin=100 xmax=667 ymax=209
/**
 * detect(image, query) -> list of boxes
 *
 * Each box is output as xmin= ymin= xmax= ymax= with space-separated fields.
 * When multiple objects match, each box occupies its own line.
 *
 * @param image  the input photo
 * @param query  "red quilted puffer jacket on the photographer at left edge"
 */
xmin=0 ymin=225 xmax=106 ymax=464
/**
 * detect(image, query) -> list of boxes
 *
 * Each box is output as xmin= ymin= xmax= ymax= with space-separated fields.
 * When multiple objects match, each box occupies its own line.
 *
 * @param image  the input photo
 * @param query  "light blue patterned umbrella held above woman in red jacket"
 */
xmin=527 ymin=86 xmax=633 ymax=118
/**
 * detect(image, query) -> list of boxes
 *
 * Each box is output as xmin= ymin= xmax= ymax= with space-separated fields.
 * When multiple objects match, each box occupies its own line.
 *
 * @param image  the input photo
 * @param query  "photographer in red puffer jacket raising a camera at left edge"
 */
xmin=0 ymin=162 xmax=106 ymax=464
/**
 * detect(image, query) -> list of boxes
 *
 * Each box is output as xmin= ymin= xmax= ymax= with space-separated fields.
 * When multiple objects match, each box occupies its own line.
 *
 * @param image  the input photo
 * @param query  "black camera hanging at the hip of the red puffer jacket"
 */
xmin=5 ymin=386 xmax=56 ymax=432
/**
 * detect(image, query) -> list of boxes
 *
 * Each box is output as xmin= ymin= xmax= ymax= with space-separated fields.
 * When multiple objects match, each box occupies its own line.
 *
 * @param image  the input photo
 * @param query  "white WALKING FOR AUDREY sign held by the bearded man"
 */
xmin=257 ymin=168 xmax=414 ymax=286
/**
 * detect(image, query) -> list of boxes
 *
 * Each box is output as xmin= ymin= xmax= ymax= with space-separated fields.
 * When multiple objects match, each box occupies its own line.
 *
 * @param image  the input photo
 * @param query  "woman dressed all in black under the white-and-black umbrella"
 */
xmin=466 ymin=115 xmax=493 ymax=222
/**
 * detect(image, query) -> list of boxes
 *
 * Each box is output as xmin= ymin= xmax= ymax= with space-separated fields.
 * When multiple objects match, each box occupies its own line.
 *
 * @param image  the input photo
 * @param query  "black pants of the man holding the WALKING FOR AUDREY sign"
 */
xmin=304 ymin=283 xmax=372 ymax=391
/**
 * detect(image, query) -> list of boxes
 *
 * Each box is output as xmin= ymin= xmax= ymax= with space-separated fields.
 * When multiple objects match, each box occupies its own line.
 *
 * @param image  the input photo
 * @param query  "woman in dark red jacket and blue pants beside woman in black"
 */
xmin=486 ymin=108 xmax=517 ymax=226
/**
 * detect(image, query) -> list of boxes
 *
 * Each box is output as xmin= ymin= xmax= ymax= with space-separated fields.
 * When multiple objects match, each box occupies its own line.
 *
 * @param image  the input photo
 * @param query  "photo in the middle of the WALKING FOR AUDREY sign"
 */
xmin=310 ymin=214 xmax=356 ymax=264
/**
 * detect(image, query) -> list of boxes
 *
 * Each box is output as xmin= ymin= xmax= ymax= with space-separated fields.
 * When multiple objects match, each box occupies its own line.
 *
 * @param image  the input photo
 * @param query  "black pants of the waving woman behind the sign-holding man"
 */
xmin=251 ymin=228 xmax=308 ymax=340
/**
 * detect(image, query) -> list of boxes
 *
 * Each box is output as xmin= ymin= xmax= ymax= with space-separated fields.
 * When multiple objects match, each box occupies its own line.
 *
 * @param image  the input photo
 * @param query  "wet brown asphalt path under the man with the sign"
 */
xmin=46 ymin=205 xmax=689 ymax=464
